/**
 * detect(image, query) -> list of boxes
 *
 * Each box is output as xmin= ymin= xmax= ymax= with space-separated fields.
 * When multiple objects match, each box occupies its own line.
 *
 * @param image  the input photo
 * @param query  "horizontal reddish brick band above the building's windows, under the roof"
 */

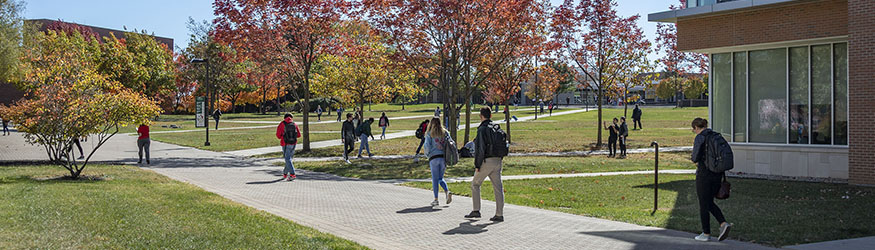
xmin=677 ymin=0 xmax=848 ymax=50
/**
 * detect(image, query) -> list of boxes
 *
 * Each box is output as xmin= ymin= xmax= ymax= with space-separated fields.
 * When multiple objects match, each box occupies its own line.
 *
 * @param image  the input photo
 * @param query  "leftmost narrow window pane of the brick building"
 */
xmin=711 ymin=53 xmax=732 ymax=139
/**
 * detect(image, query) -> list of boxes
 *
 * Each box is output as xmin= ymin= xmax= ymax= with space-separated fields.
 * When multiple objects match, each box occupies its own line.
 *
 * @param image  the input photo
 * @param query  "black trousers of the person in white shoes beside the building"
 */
xmin=696 ymin=170 xmax=726 ymax=234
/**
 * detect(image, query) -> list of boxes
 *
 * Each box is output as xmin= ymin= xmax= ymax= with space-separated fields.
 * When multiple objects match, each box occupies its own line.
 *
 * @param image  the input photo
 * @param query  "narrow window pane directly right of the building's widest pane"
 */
xmin=790 ymin=46 xmax=809 ymax=144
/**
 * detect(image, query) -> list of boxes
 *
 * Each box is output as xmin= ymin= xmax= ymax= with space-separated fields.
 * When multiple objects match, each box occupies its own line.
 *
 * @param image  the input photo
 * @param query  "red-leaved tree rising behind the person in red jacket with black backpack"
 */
xmin=213 ymin=0 xmax=352 ymax=152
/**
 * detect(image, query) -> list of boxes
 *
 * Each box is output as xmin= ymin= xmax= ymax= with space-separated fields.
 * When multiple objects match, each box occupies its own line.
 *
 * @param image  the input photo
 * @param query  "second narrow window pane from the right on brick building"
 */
xmin=811 ymin=44 xmax=832 ymax=144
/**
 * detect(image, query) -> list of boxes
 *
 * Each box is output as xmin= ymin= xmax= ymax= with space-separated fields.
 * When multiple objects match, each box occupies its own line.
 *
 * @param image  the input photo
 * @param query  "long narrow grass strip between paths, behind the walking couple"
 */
xmin=290 ymin=151 xmax=695 ymax=180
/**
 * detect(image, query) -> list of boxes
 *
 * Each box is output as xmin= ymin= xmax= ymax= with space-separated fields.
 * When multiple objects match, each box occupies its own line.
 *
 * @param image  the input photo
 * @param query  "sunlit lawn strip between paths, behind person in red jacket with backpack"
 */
xmin=150 ymin=128 xmax=340 ymax=152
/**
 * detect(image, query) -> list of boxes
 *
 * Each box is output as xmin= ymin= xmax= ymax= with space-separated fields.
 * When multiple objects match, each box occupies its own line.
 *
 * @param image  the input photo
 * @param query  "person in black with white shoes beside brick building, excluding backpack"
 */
xmin=691 ymin=118 xmax=732 ymax=241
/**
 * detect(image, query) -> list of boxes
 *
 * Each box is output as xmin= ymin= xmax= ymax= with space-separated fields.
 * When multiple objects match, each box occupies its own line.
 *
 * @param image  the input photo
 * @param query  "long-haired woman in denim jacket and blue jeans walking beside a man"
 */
xmin=425 ymin=118 xmax=453 ymax=206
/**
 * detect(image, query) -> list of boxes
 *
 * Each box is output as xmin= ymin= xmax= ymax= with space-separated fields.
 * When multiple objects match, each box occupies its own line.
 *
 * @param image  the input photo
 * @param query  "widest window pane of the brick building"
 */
xmin=748 ymin=48 xmax=787 ymax=143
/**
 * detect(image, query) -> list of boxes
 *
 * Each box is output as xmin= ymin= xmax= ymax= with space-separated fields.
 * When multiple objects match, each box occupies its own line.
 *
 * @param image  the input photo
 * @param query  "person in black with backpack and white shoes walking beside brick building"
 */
xmin=691 ymin=118 xmax=733 ymax=241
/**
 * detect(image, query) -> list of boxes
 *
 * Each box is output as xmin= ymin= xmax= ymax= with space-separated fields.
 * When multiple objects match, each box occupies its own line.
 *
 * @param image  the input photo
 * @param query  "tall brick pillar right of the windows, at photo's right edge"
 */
xmin=848 ymin=0 xmax=875 ymax=185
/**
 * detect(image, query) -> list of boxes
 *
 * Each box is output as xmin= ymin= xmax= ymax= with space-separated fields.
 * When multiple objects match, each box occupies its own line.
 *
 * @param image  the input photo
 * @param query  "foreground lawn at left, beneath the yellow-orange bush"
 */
xmin=0 ymin=165 xmax=365 ymax=249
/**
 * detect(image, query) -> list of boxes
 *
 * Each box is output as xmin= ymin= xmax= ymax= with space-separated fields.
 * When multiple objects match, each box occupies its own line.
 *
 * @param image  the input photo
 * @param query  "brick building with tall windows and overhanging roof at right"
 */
xmin=649 ymin=0 xmax=875 ymax=185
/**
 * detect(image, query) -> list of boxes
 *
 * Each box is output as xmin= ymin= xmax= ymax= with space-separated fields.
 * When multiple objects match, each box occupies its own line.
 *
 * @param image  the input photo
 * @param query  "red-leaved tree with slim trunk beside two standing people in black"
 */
xmin=552 ymin=0 xmax=650 ymax=147
